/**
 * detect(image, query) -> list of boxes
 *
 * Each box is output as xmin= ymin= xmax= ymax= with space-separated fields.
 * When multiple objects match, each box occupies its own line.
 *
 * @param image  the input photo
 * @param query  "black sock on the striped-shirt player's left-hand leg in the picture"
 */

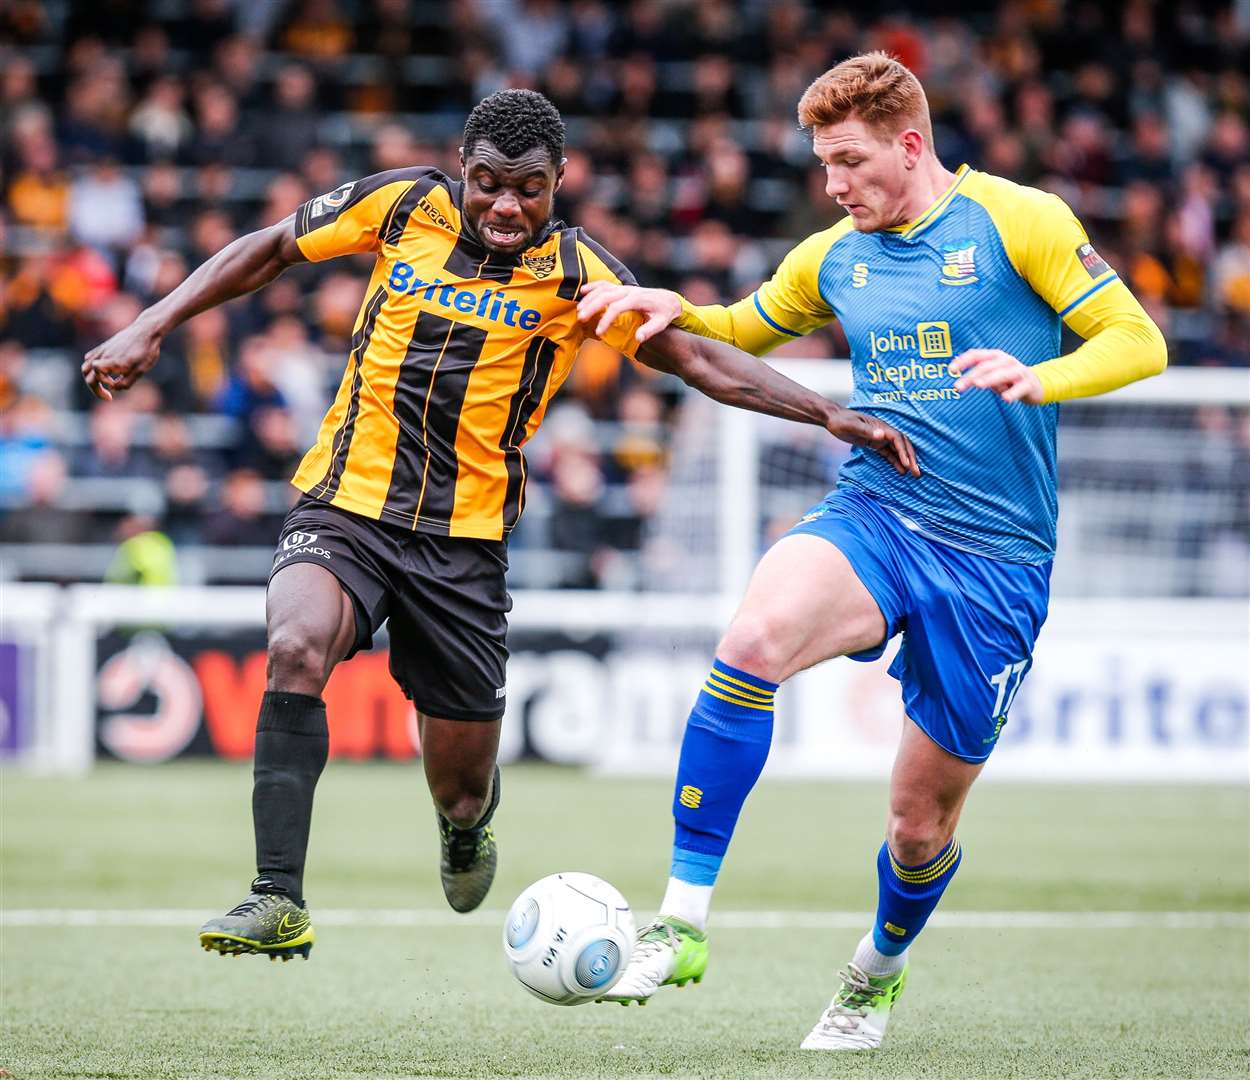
xmin=251 ymin=690 xmax=330 ymax=904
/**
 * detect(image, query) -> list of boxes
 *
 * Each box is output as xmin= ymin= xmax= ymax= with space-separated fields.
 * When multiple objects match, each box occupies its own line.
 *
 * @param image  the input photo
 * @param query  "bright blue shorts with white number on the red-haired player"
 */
xmin=786 ymin=488 xmax=1050 ymax=763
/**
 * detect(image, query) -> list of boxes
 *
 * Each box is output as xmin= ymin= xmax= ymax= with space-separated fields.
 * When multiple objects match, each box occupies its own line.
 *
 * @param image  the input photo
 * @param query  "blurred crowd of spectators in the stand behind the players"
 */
xmin=0 ymin=0 xmax=1250 ymax=586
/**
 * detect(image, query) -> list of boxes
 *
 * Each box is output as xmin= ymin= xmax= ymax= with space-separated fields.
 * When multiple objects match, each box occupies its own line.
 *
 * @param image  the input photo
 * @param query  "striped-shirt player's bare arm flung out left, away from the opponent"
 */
xmin=83 ymin=214 xmax=305 ymax=401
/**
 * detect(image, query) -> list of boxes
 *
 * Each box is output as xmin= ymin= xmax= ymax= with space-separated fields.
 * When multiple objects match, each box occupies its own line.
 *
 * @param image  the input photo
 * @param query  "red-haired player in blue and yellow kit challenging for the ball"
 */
xmin=580 ymin=53 xmax=1166 ymax=1050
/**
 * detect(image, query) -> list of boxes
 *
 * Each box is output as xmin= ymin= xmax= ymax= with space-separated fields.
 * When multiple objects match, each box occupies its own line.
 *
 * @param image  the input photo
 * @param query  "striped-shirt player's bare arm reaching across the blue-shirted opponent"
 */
xmin=629 ymin=327 xmax=920 ymax=476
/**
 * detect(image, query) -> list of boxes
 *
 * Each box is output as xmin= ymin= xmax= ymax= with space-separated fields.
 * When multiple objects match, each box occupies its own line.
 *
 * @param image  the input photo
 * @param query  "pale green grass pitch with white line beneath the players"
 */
xmin=0 ymin=763 xmax=1250 ymax=1080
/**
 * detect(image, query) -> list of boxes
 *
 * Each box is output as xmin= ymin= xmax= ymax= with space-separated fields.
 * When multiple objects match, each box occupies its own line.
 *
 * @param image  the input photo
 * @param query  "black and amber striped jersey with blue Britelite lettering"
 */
xmin=291 ymin=168 xmax=641 ymax=540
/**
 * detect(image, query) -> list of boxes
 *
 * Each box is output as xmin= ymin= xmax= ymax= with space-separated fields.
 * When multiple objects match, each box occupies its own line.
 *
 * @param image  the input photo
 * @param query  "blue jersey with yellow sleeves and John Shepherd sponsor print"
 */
xmin=675 ymin=165 xmax=1166 ymax=564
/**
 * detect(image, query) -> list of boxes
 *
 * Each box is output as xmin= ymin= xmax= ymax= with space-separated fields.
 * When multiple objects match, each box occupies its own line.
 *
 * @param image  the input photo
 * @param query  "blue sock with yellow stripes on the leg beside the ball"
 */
xmin=671 ymin=659 xmax=778 ymax=886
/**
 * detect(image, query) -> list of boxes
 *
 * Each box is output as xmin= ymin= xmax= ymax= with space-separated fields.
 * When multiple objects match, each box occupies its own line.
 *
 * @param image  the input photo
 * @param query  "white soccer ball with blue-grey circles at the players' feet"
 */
xmin=504 ymin=873 xmax=634 ymax=1005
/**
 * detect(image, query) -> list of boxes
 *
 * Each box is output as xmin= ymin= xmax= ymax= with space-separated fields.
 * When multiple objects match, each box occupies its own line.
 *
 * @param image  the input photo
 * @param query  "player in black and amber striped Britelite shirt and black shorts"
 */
xmin=83 ymin=90 xmax=916 ymax=959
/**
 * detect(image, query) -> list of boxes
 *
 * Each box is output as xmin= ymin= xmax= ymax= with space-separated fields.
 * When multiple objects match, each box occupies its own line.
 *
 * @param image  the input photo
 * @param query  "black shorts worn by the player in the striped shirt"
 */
xmin=269 ymin=495 xmax=513 ymax=720
